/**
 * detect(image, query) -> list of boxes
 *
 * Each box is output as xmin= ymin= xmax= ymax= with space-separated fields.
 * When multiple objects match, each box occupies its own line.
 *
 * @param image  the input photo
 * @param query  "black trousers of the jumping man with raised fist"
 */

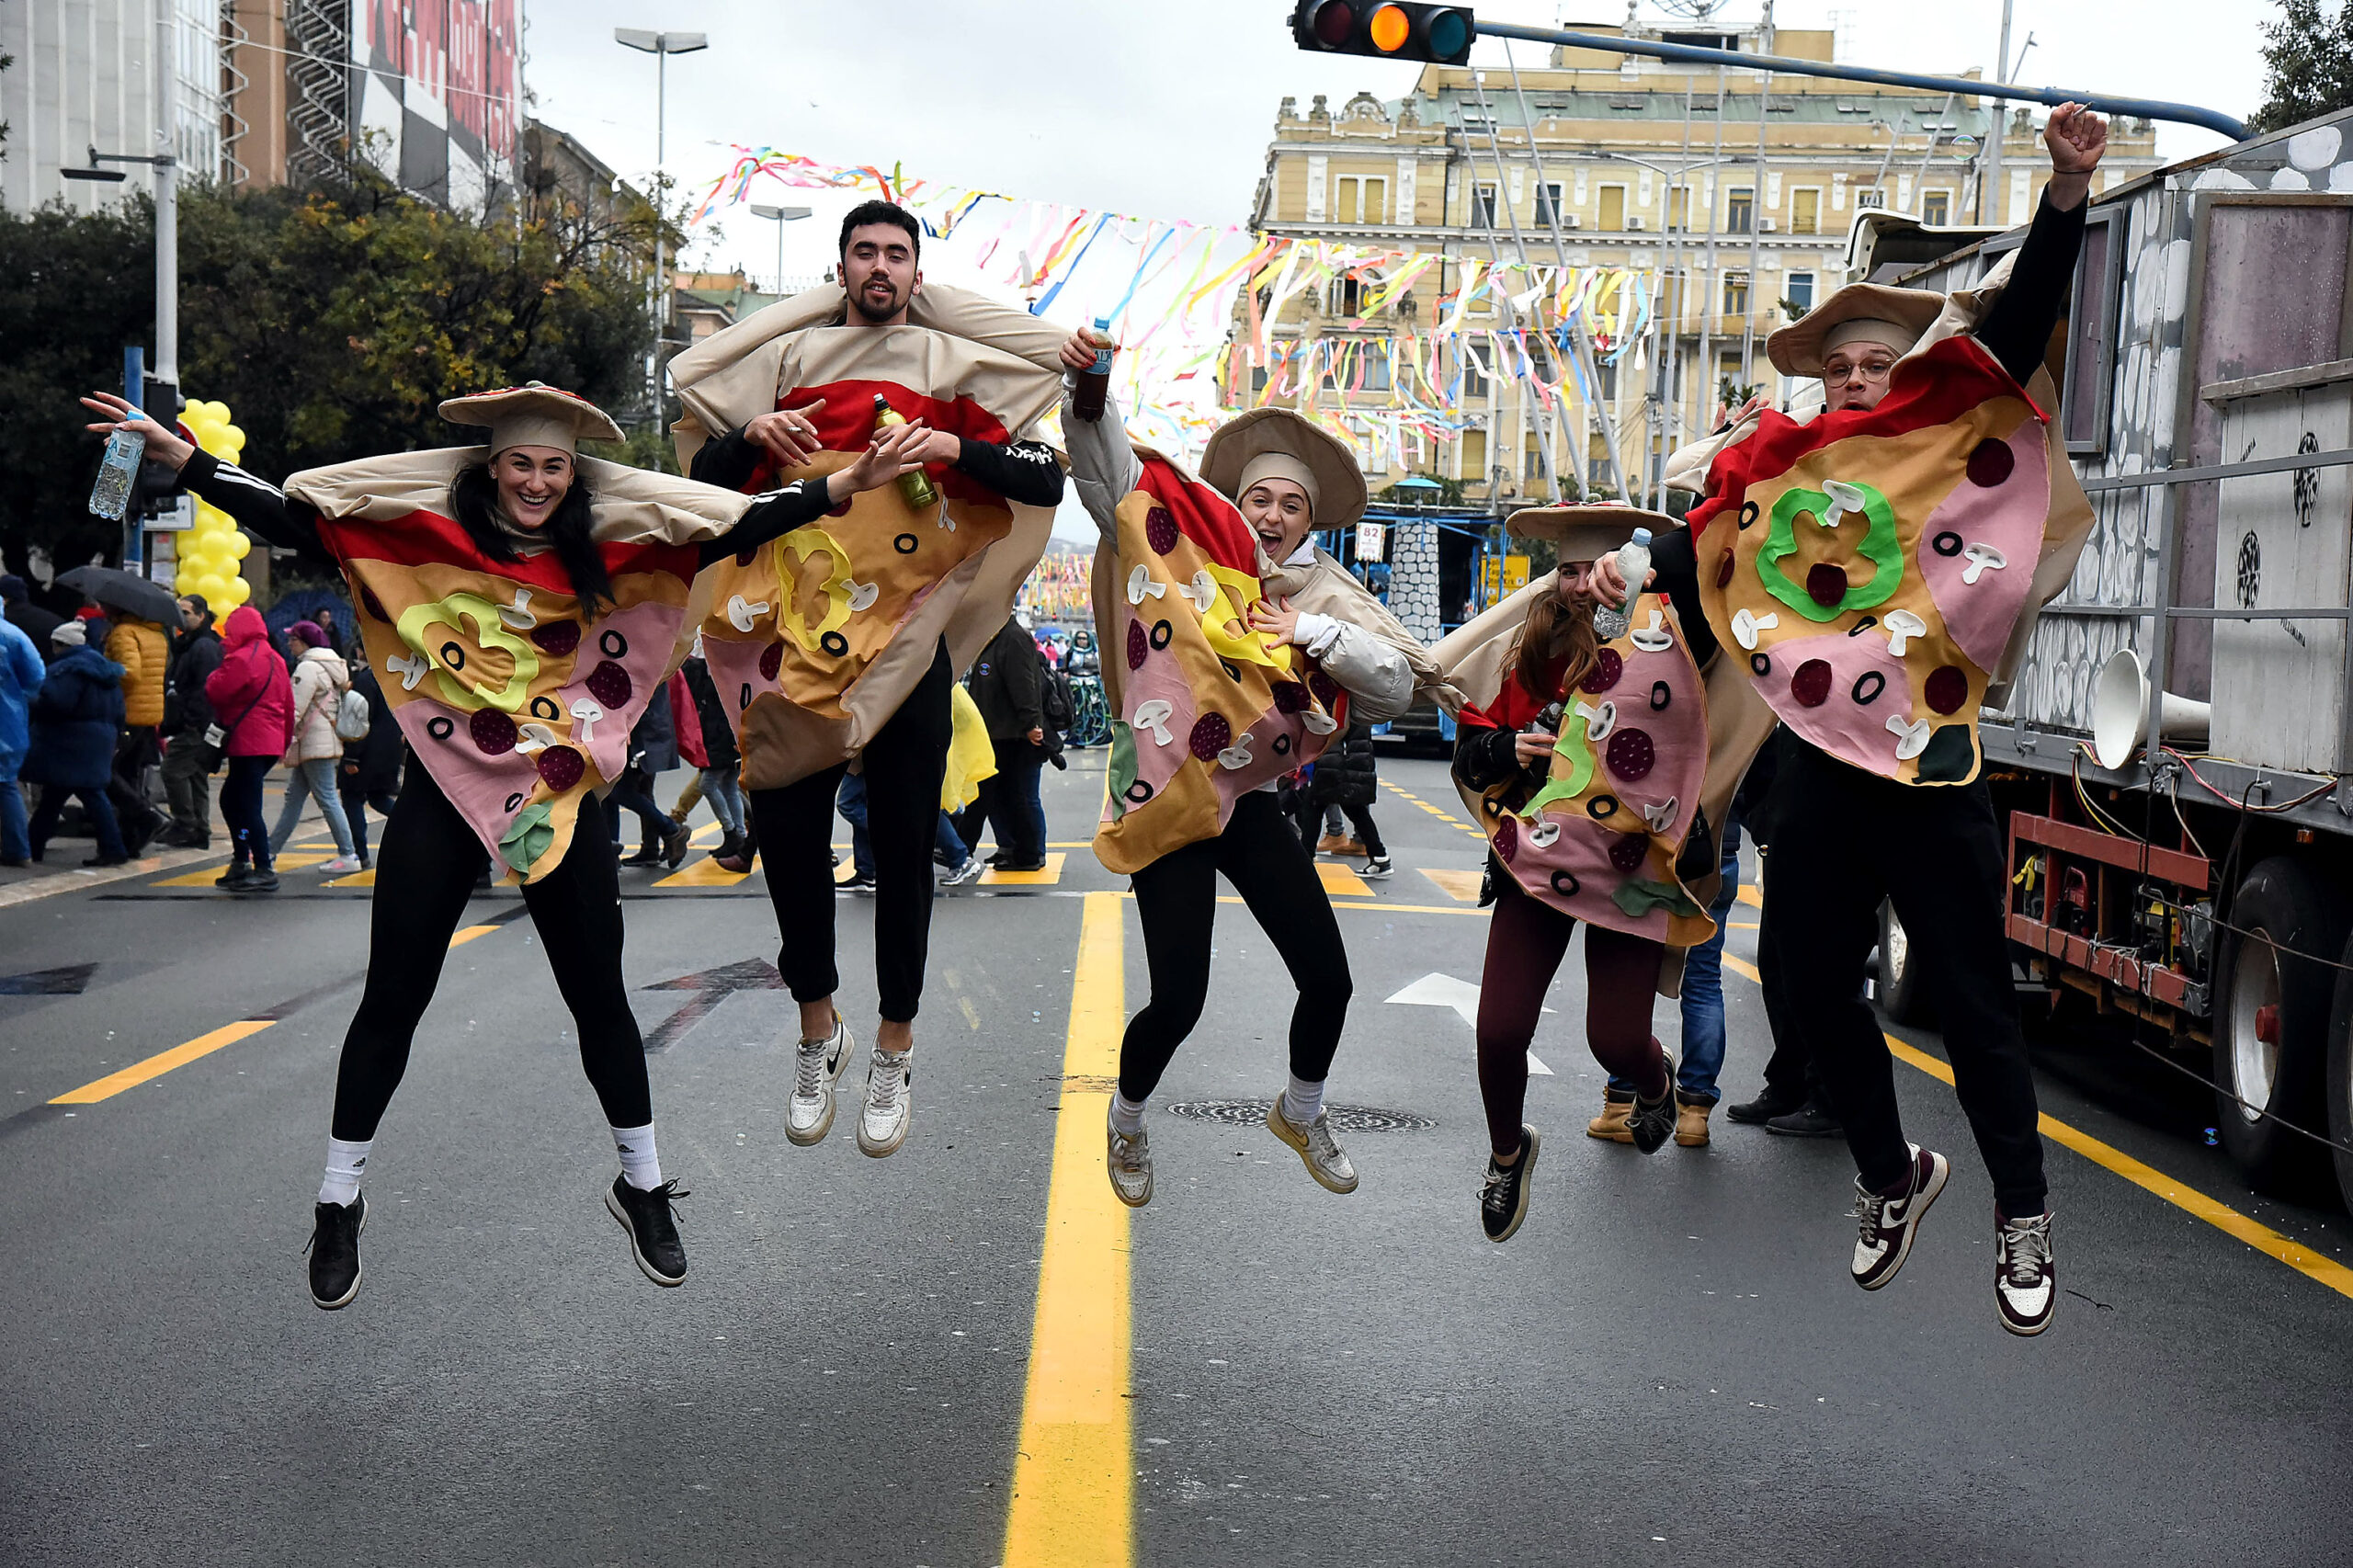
xmin=1768 ymin=746 xmax=2045 ymax=1217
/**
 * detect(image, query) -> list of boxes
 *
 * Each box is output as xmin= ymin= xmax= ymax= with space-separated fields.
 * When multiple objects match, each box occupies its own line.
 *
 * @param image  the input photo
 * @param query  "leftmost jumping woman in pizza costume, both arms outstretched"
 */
xmin=85 ymin=384 xmax=923 ymax=1309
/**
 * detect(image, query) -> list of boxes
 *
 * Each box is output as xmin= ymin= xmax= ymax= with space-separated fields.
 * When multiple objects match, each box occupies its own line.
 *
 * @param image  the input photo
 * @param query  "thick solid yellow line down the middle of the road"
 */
xmin=1005 ymin=892 xmax=1136 ymax=1568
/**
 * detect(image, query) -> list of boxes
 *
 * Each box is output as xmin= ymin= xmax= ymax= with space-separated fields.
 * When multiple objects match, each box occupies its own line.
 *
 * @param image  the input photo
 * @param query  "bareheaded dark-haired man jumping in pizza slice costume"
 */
xmin=671 ymin=202 xmax=1062 ymax=1158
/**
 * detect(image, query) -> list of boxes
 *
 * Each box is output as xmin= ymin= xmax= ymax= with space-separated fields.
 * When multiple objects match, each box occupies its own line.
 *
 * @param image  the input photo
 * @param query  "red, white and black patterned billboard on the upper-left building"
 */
xmin=350 ymin=0 xmax=522 ymax=207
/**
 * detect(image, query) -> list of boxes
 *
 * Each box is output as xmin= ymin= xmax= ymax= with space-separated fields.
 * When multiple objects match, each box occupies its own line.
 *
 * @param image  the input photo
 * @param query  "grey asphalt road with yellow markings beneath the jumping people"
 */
xmin=0 ymin=754 xmax=2353 ymax=1565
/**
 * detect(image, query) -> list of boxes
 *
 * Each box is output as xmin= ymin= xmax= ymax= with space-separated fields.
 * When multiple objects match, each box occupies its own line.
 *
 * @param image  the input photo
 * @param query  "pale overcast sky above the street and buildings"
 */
xmin=527 ymin=0 xmax=2278 ymax=534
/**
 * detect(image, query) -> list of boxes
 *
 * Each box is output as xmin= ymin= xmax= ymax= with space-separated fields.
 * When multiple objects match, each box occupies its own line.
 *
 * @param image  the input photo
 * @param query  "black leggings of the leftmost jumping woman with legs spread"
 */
xmin=326 ymin=758 xmax=654 ymax=1142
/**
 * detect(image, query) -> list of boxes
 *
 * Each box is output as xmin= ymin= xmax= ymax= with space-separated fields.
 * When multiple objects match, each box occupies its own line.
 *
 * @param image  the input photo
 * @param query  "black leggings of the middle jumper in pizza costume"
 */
xmin=1120 ymin=789 xmax=1356 ymax=1099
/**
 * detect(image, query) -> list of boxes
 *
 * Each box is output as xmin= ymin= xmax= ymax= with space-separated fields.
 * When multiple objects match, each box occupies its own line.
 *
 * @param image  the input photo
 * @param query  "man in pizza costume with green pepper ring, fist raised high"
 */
xmin=1668 ymin=104 xmax=2106 ymax=1335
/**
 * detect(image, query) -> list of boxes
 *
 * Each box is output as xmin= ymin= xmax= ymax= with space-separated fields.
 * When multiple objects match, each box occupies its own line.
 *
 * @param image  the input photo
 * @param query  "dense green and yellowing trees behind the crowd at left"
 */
xmin=0 ymin=158 xmax=652 ymax=572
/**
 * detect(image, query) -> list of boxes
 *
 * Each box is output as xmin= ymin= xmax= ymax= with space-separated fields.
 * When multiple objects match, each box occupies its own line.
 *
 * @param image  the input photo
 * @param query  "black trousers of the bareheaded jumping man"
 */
xmin=746 ymin=641 xmax=955 ymax=1024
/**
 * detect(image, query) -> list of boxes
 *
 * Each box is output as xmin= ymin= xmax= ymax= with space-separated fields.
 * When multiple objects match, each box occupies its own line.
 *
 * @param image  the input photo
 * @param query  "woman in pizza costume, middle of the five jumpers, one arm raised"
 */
xmin=1063 ymin=358 xmax=1454 ymax=1208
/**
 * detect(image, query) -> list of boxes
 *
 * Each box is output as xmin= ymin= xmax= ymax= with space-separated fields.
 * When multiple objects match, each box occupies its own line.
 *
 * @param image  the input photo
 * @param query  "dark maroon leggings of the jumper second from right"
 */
xmin=1478 ymin=871 xmax=1665 ymax=1153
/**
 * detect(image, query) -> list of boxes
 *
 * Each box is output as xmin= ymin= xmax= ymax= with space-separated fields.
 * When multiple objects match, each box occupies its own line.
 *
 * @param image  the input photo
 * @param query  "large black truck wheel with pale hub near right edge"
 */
xmin=2214 ymin=855 xmax=2346 ymax=1191
